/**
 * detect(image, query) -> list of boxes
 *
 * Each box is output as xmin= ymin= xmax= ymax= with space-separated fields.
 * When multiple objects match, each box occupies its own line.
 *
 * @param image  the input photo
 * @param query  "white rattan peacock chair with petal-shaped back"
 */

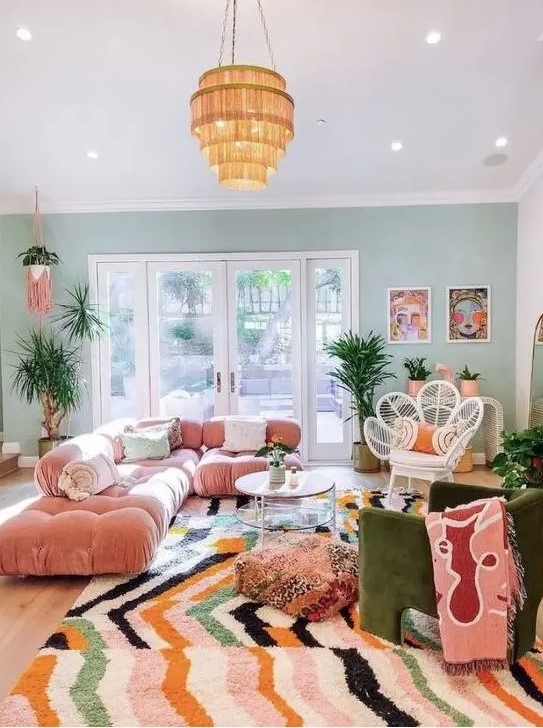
xmin=364 ymin=381 xmax=484 ymax=502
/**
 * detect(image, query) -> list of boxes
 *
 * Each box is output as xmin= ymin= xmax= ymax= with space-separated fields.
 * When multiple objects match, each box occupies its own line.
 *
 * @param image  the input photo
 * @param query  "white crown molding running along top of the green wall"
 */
xmin=0 ymin=189 xmax=518 ymax=215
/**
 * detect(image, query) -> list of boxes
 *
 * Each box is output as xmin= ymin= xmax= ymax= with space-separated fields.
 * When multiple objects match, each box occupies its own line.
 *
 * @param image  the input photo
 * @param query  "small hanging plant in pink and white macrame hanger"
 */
xmin=17 ymin=187 xmax=61 ymax=314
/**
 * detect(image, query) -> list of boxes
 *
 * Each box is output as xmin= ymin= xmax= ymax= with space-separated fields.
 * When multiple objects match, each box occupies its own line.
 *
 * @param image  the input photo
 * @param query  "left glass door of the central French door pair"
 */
xmin=149 ymin=263 xmax=226 ymax=420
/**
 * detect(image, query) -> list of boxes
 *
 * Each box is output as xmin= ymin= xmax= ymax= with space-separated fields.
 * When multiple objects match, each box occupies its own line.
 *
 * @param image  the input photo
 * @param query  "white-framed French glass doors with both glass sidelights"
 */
xmin=91 ymin=254 xmax=357 ymax=461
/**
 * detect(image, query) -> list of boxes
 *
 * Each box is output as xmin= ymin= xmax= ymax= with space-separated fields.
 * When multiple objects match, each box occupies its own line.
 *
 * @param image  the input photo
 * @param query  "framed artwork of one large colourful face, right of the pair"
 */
xmin=447 ymin=286 xmax=490 ymax=344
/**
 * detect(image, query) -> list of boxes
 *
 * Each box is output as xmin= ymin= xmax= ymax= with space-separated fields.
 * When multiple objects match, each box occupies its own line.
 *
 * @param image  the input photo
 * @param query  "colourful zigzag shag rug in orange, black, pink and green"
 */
xmin=0 ymin=491 xmax=543 ymax=726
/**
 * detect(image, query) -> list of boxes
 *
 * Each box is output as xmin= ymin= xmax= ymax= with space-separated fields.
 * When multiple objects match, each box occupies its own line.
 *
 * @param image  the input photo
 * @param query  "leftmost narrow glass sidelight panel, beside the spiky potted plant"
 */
xmin=96 ymin=263 xmax=149 ymax=424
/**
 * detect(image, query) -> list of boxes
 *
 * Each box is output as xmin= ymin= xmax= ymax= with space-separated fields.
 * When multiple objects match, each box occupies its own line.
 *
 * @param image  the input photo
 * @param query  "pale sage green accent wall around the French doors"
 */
xmin=0 ymin=204 xmax=517 ymax=455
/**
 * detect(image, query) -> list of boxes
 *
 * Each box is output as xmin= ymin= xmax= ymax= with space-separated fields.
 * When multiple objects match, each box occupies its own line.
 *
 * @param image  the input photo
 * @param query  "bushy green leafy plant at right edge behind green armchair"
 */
xmin=492 ymin=425 xmax=543 ymax=488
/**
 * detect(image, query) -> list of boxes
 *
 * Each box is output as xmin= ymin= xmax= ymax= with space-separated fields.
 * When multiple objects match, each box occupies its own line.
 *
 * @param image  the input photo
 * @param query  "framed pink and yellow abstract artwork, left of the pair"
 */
xmin=387 ymin=287 xmax=432 ymax=344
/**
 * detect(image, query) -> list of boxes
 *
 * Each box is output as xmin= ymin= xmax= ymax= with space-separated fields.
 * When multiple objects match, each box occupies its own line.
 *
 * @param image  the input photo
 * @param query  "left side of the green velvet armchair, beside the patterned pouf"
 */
xmin=359 ymin=508 xmax=436 ymax=643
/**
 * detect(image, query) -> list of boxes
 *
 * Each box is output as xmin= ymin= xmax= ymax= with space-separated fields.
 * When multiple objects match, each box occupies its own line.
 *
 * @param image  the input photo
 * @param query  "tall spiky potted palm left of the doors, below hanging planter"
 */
xmin=13 ymin=285 xmax=105 ymax=457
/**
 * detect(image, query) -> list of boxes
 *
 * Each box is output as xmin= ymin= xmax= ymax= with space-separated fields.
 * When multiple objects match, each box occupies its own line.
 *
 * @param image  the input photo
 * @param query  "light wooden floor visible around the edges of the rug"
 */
xmin=0 ymin=466 xmax=516 ymax=700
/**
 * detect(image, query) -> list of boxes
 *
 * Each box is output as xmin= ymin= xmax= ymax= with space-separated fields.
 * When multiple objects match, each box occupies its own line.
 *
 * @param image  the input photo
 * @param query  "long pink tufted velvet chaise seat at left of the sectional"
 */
xmin=0 ymin=464 xmax=188 ymax=576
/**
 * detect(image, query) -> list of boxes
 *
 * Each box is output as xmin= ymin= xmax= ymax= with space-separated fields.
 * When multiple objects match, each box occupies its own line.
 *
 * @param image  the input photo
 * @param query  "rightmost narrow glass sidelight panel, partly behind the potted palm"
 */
xmin=307 ymin=260 xmax=352 ymax=460
